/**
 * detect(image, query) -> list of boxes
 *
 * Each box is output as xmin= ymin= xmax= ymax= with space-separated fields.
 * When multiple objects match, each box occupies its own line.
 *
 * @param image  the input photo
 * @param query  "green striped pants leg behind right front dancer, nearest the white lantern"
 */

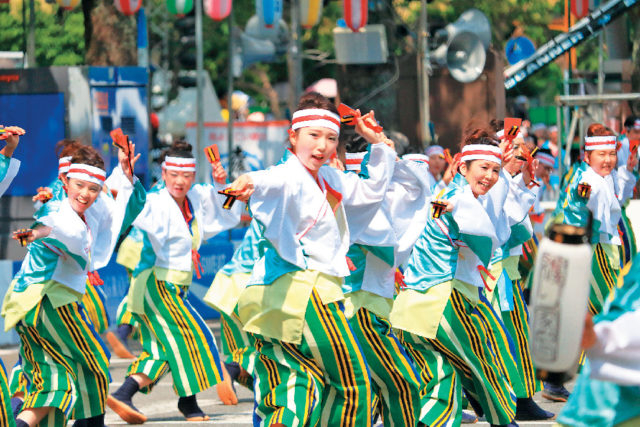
xmin=476 ymin=286 xmax=530 ymax=398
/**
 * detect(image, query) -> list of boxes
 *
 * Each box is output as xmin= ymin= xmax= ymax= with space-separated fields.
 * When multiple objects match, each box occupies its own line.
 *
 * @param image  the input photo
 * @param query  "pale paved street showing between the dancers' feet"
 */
xmin=0 ymin=321 xmax=571 ymax=427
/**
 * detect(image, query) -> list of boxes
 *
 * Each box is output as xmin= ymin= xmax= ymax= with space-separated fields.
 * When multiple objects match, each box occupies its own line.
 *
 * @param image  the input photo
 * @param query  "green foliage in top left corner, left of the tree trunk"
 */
xmin=0 ymin=2 xmax=84 ymax=67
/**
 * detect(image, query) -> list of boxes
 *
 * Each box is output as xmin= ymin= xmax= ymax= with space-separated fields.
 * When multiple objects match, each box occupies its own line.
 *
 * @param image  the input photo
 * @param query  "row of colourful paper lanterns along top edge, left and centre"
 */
xmin=56 ymin=0 xmax=367 ymax=31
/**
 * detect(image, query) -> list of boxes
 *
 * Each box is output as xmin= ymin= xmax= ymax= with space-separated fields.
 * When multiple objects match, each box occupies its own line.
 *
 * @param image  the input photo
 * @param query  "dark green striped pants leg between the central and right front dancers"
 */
xmin=349 ymin=308 xmax=420 ymax=426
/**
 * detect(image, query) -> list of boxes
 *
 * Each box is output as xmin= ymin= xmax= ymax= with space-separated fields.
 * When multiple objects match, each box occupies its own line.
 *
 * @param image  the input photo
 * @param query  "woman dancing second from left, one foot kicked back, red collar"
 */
xmin=107 ymin=141 xmax=242 ymax=424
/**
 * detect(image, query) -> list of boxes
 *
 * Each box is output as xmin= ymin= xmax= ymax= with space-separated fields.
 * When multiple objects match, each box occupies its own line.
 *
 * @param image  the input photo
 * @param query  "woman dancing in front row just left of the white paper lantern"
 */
xmin=391 ymin=129 xmax=515 ymax=427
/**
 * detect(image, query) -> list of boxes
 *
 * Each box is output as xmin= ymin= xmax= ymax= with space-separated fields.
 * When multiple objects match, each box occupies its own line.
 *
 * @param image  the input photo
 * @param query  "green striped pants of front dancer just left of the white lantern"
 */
xmin=403 ymin=289 xmax=516 ymax=426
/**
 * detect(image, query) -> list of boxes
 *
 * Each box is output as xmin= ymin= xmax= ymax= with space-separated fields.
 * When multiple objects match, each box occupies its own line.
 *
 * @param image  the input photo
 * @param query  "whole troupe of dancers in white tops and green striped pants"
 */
xmin=0 ymin=93 xmax=640 ymax=427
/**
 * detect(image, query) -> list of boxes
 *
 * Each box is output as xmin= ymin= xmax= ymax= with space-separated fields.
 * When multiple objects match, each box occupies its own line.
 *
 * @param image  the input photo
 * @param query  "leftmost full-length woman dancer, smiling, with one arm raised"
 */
xmin=2 ymin=145 xmax=145 ymax=426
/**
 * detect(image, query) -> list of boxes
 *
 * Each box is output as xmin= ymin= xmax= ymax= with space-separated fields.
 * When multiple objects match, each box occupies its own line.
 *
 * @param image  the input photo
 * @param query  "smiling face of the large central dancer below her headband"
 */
xmin=289 ymin=126 xmax=338 ymax=178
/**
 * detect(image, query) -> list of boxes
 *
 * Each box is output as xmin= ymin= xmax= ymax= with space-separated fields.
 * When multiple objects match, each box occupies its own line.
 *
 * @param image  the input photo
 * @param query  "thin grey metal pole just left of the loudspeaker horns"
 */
xmin=417 ymin=0 xmax=431 ymax=148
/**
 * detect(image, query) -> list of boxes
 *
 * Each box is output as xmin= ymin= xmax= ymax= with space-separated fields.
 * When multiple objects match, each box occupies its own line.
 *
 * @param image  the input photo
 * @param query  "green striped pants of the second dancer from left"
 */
xmin=127 ymin=274 xmax=222 ymax=397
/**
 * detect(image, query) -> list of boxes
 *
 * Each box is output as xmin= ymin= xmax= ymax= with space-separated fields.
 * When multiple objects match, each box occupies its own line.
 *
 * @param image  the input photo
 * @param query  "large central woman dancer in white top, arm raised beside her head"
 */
xmin=225 ymin=93 xmax=396 ymax=426
